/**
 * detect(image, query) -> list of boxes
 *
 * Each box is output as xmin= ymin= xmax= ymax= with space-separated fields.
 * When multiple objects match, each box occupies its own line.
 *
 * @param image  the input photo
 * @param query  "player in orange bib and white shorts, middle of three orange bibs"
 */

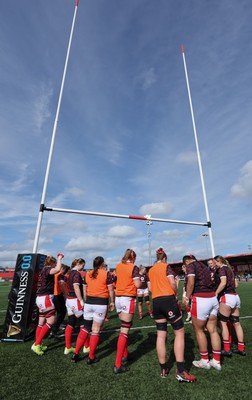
xmin=114 ymin=249 xmax=141 ymax=374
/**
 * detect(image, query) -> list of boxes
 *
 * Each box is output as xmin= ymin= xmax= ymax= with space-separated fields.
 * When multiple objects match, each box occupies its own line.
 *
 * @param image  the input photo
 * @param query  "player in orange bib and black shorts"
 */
xmin=149 ymin=248 xmax=196 ymax=383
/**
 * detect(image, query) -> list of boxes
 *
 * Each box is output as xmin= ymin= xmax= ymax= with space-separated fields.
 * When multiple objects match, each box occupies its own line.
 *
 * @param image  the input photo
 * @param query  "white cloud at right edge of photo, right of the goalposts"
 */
xmin=231 ymin=160 xmax=252 ymax=198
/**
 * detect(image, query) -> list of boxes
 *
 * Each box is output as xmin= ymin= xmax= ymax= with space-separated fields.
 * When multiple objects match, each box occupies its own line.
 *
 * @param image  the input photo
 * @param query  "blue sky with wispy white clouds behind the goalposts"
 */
xmin=0 ymin=0 xmax=252 ymax=268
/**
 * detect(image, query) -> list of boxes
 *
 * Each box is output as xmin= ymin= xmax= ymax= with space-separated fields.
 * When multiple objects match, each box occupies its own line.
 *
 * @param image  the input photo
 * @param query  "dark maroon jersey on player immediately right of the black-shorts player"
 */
xmin=186 ymin=261 xmax=215 ymax=294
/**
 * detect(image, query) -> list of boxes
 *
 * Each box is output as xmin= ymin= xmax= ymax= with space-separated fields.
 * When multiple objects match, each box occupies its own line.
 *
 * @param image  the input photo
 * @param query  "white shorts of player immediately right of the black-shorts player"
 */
xmin=191 ymin=296 xmax=219 ymax=321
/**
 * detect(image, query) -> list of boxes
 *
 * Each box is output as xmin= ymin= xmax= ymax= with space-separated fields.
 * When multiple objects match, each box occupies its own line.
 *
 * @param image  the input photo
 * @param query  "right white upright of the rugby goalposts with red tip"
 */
xmin=181 ymin=45 xmax=215 ymax=257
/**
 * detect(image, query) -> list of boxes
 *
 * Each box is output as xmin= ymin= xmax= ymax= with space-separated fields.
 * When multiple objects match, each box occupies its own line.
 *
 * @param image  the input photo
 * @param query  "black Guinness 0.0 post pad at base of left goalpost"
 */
xmin=2 ymin=254 xmax=46 ymax=342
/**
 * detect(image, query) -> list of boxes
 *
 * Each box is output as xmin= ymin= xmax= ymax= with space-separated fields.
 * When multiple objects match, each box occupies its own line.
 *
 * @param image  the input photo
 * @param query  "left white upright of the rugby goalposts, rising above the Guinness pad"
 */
xmin=33 ymin=0 xmax=79 ymax=253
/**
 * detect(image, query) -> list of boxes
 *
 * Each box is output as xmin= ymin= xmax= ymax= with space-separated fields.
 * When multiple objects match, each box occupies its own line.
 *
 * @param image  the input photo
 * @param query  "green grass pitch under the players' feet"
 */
xmin=0 ymin=282 xmax=252 ymax=400
